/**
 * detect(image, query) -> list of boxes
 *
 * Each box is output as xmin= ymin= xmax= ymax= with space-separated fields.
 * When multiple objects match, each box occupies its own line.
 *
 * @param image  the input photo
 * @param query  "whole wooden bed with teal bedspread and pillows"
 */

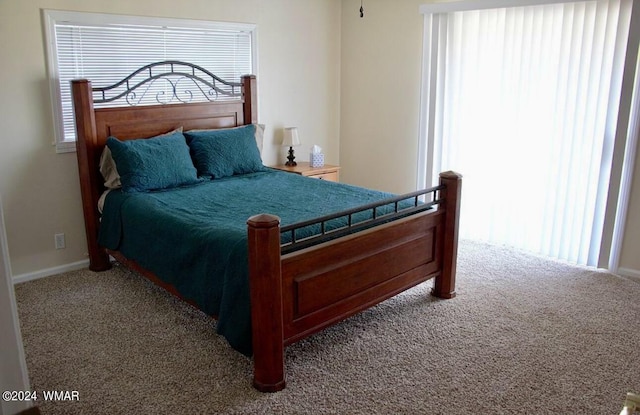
xmin=72 ymin=61 xmax=461 ymax=392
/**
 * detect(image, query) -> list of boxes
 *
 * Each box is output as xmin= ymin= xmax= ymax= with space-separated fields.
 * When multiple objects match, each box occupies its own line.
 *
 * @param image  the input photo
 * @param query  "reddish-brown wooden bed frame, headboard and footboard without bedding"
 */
xmin=72 ymin=62 xmax=461 ymax=392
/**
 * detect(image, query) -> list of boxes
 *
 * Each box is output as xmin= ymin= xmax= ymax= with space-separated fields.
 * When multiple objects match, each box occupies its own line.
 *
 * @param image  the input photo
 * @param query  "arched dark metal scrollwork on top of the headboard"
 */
xmin=92 ymin=61 xmax=242 ymax=106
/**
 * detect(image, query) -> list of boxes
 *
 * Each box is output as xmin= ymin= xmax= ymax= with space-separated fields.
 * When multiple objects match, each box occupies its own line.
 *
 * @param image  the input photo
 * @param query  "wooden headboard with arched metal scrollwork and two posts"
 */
xmin=71 ymin=61 xmax=258 ymax=271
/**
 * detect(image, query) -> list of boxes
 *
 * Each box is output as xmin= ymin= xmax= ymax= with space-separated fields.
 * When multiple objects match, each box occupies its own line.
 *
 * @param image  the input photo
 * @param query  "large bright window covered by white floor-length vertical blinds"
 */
xmin=418 ymin=0 xmax=638 ymax=268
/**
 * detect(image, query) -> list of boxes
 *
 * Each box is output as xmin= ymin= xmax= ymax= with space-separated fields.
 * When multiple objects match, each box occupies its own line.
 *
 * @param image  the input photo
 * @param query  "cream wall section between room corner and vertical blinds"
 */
xmin=340 ymin=0 xmax=425 ymax=193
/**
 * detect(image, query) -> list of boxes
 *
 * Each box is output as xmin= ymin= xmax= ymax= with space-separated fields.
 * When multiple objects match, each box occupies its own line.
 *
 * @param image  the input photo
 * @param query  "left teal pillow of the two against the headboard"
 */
xmin=107 ymin=132 xmax=199 ymax=193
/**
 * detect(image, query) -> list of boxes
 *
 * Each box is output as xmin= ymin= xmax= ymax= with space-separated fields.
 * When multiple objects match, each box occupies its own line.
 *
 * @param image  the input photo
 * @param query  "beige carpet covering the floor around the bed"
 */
xmin=16 ymin=241 xmax=640 ymax=415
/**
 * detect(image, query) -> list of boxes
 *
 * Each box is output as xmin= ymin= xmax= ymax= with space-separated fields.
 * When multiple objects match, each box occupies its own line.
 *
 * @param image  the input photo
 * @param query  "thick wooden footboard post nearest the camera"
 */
xmin=247 ymin=214 xmax=285 ymax=392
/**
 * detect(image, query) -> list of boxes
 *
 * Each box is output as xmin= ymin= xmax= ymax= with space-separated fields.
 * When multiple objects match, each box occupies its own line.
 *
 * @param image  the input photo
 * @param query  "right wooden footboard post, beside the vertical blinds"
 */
xmin=432 ymin=171 xmax=462 ymax=298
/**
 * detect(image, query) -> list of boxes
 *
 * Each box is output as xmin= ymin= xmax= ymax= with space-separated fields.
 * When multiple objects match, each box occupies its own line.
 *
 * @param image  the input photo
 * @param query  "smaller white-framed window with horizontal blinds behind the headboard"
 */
xmin=43 ymin=10 xmax=256 ymax=152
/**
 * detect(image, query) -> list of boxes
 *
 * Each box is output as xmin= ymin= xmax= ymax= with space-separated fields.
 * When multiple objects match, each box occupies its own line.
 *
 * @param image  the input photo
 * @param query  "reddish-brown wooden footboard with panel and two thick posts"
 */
xmin=248 ymin=172 xmax=461 ymax=392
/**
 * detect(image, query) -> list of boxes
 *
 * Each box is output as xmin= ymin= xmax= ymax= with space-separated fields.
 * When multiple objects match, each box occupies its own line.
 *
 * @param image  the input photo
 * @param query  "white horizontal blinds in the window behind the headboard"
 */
xmin=55 ymin=22 xmax=252 ymax=142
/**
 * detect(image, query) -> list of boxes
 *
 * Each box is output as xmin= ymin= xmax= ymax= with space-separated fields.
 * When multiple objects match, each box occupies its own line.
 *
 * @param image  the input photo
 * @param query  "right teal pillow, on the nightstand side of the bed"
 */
xmin=184 ymin=124 xmax=265 ymax=179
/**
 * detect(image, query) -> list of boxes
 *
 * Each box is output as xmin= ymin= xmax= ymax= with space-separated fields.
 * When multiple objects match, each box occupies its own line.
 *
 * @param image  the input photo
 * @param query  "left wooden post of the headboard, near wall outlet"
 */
xmin=71 ymin=79 xmax=111 ymax=271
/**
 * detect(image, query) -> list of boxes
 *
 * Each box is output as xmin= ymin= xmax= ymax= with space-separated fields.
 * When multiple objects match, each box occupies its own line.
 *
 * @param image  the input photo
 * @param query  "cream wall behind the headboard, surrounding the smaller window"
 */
xmin=0 ymin=0 xmax=340 ymax=277
